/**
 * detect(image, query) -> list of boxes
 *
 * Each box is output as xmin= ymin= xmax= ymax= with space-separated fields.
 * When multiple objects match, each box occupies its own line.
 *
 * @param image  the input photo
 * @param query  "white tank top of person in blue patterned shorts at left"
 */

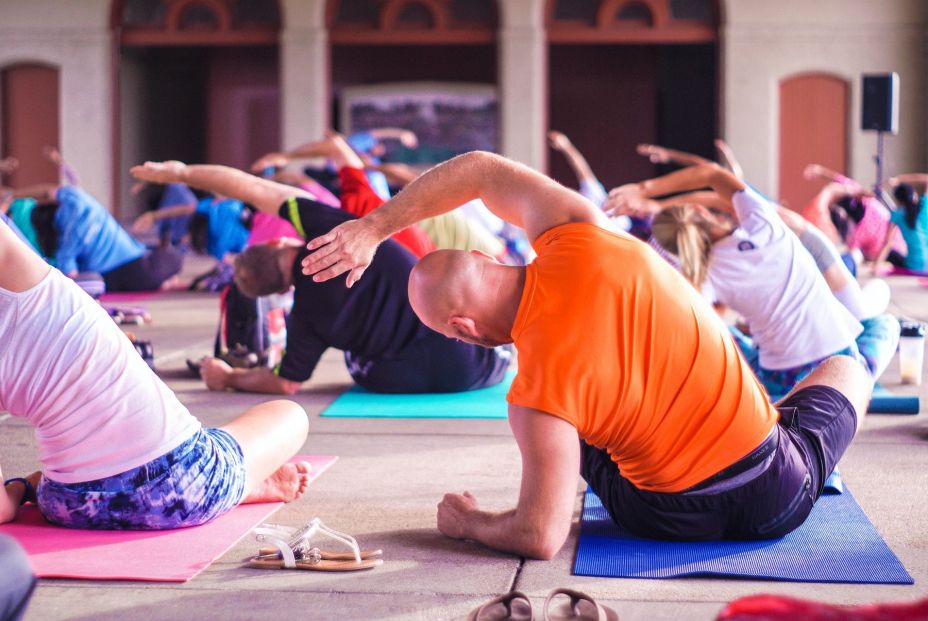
xmin=0 ymin=269 xmax=200 ymax=483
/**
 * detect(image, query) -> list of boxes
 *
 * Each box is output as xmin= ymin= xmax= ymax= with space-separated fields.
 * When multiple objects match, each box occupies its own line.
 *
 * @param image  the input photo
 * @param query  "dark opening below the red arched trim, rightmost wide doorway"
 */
xmin=549 ymin=44 xmax=717 ymax=190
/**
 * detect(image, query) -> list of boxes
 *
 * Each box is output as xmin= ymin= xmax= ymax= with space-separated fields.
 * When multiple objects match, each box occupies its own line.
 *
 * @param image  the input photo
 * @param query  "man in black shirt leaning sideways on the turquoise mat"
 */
xmin=132 ymin=157 xmax=510 ymax=394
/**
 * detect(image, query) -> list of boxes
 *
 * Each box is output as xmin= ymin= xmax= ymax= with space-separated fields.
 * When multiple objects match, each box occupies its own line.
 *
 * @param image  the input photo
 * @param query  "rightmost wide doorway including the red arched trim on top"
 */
xmin=546 ymin=0 xmax=719 ymax=189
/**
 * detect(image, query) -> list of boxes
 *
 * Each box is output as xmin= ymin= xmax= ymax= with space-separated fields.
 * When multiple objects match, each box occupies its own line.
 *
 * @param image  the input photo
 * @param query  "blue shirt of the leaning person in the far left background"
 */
xmin=55 ymin=185 xmax=145 ymax=274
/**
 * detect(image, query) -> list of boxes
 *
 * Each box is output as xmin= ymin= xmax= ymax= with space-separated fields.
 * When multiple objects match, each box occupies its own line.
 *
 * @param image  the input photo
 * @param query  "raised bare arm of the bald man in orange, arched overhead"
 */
xmin=303 ymin=151 xmax=612 ymax=287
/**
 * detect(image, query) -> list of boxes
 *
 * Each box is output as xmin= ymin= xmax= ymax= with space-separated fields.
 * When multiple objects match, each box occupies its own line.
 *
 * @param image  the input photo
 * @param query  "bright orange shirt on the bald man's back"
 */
xmin=509 ymin=224 xmax=776 ymax=492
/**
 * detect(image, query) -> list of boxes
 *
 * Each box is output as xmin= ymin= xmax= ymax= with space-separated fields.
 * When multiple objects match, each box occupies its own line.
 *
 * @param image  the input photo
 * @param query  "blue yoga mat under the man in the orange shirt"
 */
xmin=573 ymin=487 xmax=914 ymax=584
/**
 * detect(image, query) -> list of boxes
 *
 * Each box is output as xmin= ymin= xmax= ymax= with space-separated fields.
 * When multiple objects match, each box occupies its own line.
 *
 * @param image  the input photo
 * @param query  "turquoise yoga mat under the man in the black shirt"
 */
xmin=322 ymin=371 xmax=515 ymax=418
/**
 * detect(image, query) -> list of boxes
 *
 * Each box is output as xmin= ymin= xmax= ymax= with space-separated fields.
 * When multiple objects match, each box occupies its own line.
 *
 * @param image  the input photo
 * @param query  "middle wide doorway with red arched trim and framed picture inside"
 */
xmin=326 ymin=0 xmax=498 ymax=163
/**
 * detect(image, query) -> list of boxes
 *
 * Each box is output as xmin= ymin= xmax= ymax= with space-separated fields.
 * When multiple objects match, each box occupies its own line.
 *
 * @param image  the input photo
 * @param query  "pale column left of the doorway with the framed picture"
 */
xmin=280 ymin=0 xmax=330 ymax=148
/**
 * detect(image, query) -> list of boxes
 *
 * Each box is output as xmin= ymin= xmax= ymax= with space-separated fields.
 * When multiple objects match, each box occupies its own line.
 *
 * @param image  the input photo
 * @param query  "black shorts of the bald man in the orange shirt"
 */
xmin=580 ymin=386 xmax=857 ymax=540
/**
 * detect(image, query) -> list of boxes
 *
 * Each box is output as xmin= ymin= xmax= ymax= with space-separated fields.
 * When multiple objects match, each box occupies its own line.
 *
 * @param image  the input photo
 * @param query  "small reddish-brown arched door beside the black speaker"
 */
xmin=779 ymin=73 xmax=848 ymax=210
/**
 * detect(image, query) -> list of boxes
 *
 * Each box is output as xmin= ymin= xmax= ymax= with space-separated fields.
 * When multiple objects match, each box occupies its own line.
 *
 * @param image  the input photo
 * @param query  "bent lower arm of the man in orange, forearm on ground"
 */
xmin=438 ymin=406 xmax=580 ymax=560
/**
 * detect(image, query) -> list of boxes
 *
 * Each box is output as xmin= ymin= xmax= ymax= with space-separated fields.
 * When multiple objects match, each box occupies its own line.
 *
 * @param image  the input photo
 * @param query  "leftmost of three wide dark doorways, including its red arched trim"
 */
xmin=112 ymin=0 xmax=282 ymax=215
